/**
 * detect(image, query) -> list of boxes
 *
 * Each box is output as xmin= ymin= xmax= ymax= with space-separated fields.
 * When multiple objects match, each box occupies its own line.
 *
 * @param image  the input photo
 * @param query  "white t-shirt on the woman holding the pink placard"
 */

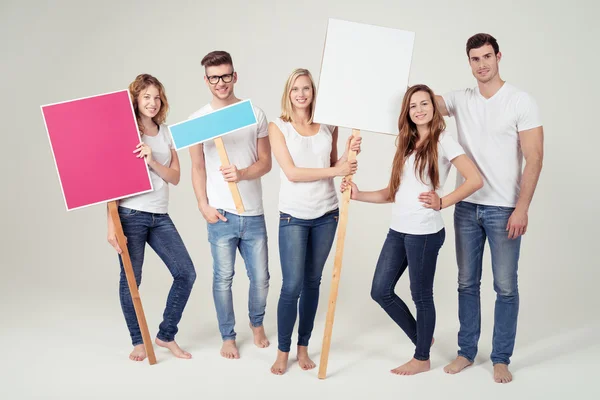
xmin=119 ymin=124 xmax=173 ymax=214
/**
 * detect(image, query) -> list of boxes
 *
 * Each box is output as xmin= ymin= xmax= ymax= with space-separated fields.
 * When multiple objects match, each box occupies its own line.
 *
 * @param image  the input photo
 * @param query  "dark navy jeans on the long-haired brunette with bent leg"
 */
xmin=371 ymin=229 xmax=446 ymax=361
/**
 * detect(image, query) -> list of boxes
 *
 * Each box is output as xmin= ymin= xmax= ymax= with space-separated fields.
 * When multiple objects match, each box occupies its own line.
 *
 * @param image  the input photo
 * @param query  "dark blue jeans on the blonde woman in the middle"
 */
xmin=277 ymin=209 xmax=339 ymax=353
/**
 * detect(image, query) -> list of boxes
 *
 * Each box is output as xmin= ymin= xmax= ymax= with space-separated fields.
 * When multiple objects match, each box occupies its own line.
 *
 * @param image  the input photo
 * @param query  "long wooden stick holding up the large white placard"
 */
xmin=318 ymin=129 xmax=360 ymax=379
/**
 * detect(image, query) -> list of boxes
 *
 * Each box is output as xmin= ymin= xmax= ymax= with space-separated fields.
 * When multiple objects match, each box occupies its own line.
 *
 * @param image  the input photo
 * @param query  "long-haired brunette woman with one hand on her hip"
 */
xmin=341 ymin=85 xmax=483 ymax=375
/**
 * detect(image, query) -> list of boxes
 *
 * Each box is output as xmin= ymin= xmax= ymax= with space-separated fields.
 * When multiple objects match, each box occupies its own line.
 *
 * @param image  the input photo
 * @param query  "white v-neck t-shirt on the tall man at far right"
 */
xmin=443 ymin=83 xmax=542 ymax=207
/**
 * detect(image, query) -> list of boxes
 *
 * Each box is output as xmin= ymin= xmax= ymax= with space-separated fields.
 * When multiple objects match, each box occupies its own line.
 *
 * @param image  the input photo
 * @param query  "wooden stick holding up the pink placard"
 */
xmin=108 ymin=201 xmax=156 ymax=365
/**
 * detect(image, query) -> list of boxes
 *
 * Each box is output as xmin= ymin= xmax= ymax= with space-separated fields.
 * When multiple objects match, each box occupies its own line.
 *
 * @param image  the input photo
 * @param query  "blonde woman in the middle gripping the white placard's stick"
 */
xmin=269 ymin=69 xmax=360 ymax=375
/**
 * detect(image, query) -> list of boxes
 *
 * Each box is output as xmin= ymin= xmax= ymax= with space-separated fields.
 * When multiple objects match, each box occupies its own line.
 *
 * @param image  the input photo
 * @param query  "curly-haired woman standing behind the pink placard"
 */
xmin=108 ymin=74 xmax=196 ymax=361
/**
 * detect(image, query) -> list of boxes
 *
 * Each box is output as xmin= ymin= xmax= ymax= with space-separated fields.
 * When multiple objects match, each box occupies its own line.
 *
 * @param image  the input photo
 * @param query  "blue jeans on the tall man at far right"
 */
xmin=454 ymin=202 xmax=521 ymax=364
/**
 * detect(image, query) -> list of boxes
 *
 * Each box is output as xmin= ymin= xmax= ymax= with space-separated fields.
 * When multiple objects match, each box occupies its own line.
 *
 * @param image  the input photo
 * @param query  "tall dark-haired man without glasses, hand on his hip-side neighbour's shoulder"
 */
xmin=436 ymin=33 xmax=543 ymax=383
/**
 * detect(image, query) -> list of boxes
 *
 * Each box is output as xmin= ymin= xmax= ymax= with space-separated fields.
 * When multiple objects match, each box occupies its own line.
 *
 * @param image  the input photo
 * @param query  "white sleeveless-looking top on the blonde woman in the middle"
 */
xmin=273 ymin=118 xmax=338 ymax=219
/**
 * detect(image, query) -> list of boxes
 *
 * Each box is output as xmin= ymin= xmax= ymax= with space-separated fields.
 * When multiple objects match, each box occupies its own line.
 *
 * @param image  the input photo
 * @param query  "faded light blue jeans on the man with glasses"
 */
xmin=207 ymin=209 xmax=269 ymax=340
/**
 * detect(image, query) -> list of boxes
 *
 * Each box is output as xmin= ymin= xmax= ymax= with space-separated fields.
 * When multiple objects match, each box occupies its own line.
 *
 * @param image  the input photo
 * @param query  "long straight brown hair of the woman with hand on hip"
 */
xmin=388 ymin=85 xmax=446 ymax=202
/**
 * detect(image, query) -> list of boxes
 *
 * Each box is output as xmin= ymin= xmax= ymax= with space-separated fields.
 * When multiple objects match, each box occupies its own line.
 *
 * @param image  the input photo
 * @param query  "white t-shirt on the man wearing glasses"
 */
xmin=190 ymin=103 xmax=268 ymax=216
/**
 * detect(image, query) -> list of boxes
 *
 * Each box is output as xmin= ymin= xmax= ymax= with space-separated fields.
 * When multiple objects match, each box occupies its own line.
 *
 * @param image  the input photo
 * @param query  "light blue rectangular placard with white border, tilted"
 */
xmin=169 ymin=100 xmax=256 ymax=150
